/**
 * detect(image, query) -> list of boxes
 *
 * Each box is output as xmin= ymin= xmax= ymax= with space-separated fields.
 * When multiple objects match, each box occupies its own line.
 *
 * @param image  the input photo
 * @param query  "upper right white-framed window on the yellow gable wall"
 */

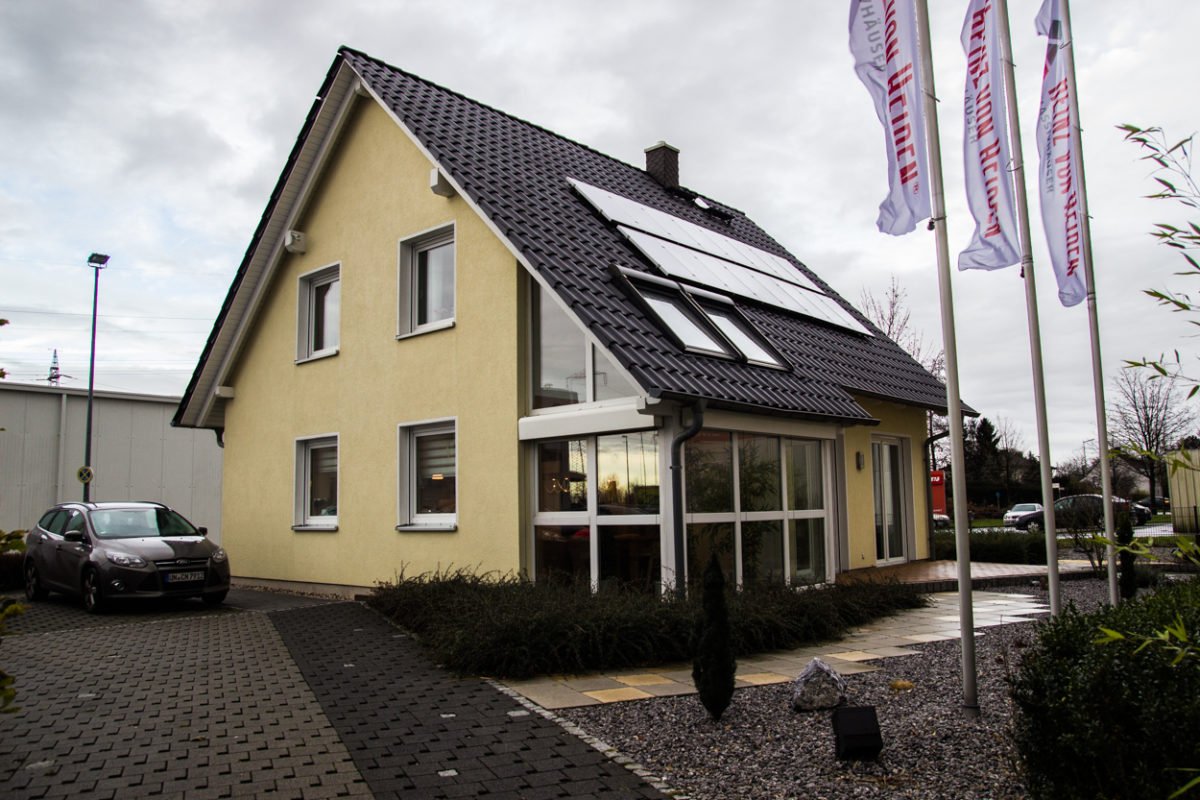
xmin=396 ymin=223 xmax=456 ymax=337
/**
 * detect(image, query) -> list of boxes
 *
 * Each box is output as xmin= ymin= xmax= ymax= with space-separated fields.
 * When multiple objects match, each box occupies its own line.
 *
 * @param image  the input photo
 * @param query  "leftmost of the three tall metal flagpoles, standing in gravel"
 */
xmin=916 ymin=0 xmax=979 ymax=716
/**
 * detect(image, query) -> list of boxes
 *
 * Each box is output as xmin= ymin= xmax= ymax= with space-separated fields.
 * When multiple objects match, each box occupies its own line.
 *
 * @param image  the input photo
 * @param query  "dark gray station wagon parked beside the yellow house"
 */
xmin=24 ymin=503 xmax=229 ymax=613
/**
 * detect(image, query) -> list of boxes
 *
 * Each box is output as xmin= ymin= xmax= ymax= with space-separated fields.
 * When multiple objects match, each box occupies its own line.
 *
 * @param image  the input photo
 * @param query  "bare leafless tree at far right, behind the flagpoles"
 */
xmin=1109 ymin=369 xmax=1196 ymax=501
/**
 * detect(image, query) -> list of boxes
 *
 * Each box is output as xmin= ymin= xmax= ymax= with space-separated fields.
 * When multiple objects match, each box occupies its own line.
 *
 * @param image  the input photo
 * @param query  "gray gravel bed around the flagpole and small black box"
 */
xmin=559 ymin=579 xmax=1108 ymax=800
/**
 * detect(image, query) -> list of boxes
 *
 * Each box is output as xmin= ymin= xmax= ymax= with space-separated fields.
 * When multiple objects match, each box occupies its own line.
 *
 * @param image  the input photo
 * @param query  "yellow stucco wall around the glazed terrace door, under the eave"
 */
xmin=842 ymin=397 xmax=929 ymax=570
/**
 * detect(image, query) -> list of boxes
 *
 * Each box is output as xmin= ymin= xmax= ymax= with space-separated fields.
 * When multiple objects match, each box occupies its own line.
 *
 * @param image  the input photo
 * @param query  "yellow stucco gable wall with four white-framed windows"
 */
xmin=223 ymin=98 xmax=521 ymax=587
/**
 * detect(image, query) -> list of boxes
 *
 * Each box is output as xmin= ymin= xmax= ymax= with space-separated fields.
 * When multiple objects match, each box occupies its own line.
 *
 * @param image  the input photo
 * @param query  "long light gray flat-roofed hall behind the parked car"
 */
xmin=0 ymin=380 xmax=222 ymax=542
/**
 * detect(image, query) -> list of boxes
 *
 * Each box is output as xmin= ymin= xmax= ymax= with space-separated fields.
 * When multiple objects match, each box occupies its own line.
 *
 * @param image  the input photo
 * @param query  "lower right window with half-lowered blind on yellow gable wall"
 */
xmin=396 ymin=420 xmax=458 ymax=530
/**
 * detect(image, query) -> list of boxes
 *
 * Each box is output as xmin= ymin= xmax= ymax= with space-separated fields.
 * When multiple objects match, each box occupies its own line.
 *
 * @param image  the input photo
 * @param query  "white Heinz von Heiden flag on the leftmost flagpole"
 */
xmin=850 ymin=0 xmax=931 ymax=236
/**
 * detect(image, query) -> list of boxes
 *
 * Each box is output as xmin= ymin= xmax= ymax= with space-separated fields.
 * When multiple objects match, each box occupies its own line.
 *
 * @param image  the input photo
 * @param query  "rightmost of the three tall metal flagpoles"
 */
xmin=1062 ymin=0 xmax=1117 ymax=606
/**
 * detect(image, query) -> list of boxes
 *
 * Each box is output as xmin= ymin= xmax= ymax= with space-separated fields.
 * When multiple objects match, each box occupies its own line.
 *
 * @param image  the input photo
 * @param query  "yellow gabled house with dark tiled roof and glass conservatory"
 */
xmin=174 ymin=48 xmax=946 ymax=590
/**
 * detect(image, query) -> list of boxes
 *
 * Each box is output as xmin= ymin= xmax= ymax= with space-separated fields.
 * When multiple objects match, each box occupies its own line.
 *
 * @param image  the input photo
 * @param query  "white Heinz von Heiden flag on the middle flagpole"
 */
xmin=959 ymin=0 xmax=1021 ymax=270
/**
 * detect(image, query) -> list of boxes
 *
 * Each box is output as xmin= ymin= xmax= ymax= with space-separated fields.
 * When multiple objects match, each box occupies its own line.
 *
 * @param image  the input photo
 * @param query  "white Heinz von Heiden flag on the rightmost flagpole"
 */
xmin=1037 ymin=0 xmax=1087 ymax=306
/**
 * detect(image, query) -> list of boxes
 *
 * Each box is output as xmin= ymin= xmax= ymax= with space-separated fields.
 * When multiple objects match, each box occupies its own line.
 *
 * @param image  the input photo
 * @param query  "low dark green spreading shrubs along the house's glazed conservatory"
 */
xmin=368 ymin=570 xmax=925 ymax=679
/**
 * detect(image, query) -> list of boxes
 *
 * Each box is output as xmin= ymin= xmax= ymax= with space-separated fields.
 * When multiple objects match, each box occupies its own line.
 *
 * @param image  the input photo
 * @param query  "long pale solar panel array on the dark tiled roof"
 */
xmin=568 ymin=179 xmax=870 ymax=335
